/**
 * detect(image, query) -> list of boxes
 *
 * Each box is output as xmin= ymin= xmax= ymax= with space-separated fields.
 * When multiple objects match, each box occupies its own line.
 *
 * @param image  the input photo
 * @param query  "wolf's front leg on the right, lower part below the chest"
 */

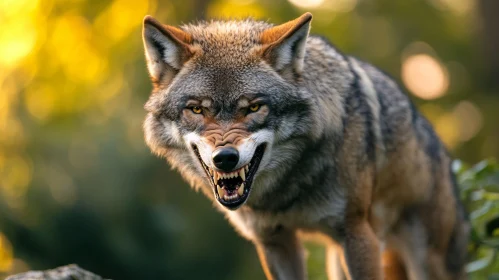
xmin=344 ymin=221 xmax=383 ymax=280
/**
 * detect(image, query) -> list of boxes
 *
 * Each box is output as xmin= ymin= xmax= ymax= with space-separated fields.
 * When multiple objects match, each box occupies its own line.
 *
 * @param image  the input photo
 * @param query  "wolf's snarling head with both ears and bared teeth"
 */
xmin=143 ymin=13 xmax=312 ymax=209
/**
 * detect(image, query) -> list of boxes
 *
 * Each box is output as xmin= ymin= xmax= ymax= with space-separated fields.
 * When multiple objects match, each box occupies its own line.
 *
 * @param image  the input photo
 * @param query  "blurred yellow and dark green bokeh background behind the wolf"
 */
xmin=0 ymin=0 xmax=499 ymax=280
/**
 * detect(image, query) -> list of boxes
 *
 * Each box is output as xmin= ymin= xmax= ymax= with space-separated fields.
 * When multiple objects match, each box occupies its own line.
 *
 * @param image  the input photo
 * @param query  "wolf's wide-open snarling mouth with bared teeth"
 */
xmin=193 ymin=144 xmax=265 ymax=210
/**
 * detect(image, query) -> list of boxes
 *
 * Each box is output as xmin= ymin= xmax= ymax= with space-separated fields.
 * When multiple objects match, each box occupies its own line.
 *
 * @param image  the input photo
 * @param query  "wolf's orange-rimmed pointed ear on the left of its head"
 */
xmin=142 ymin=16 xmax=194 ymax=82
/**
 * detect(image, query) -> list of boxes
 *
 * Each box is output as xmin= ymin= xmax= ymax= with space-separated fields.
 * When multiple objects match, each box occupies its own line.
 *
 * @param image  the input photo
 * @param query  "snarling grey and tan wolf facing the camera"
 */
xmin=143 ymin=13 xmax=469 ymax=280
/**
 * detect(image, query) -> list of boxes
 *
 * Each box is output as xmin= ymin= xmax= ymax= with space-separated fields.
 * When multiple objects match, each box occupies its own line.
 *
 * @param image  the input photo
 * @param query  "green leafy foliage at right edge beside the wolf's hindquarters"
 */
xmin=453 ymin=160 xmax=499 ymax=279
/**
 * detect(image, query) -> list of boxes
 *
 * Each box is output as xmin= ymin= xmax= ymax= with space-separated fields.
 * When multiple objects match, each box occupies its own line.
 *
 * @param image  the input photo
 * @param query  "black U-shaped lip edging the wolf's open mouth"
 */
xmin=192 ymin=143 xmax=266 ymax=210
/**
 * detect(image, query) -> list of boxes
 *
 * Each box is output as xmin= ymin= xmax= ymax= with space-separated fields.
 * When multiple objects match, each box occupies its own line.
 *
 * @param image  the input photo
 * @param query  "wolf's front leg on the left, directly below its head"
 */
xmin=254 ymin=228 xmax=307 ymax=280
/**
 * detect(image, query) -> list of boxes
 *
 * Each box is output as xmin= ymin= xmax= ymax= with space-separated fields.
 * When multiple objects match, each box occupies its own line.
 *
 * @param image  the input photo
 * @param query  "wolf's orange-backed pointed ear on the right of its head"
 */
xmin=260 ymin=13 xmax=312 ymax=73
